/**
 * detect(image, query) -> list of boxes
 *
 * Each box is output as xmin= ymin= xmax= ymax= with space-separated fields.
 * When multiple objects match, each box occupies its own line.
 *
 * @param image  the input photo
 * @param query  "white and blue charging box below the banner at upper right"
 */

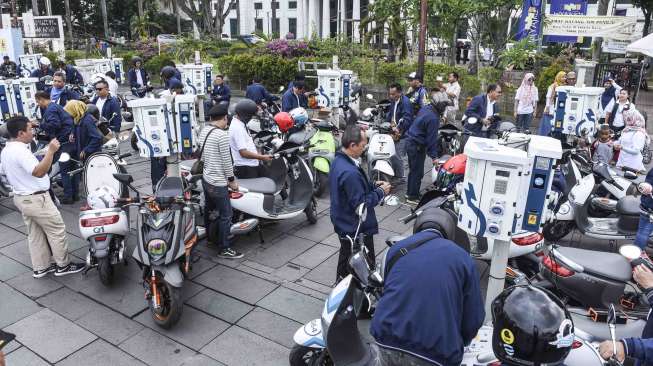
xmin=553 ymin=86 xmax=605 ymax=137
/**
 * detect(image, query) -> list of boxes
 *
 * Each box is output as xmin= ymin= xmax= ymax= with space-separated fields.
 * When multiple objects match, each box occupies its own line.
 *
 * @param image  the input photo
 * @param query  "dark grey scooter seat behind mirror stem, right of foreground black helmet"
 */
xmin=570 ymin=309 xmax=646 ymax=342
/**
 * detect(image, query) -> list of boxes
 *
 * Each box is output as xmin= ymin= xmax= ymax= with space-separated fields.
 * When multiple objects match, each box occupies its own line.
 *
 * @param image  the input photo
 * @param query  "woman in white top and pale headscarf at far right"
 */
xmin=614 ymin=108 xmax=649 ymax=170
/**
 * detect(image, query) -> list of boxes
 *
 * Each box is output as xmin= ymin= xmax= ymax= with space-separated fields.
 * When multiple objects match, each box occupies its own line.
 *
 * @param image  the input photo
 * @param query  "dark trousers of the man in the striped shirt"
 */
xmin=202 ymin=180 xmax=232 ymax=249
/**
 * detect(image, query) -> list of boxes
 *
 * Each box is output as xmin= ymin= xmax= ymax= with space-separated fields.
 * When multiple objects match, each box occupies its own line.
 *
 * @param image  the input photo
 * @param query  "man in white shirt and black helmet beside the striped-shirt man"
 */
xmin=229 ymin=99 xmax=272 ymax=179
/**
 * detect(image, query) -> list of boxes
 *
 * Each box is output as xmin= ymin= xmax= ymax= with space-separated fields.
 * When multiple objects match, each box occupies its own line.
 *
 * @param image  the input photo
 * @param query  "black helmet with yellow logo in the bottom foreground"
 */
xmin=492 ymin=285 xmax=574 ymax=366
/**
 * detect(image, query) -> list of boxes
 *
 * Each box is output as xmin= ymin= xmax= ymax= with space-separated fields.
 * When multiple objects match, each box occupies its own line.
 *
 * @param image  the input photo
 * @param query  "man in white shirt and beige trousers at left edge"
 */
xmin=0 ymin=116 xmax=84 ymax=278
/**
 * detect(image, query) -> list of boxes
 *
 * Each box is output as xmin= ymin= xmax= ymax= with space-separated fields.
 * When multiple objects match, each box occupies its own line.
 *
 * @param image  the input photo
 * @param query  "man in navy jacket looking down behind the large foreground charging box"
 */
xmin=465 ymin=84 xmax=503 ymax=137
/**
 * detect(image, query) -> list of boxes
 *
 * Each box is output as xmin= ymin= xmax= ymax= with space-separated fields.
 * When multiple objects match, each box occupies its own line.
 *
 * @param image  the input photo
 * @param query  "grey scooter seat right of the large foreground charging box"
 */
xmin=556 ymin=247 xmax=632 ymax=282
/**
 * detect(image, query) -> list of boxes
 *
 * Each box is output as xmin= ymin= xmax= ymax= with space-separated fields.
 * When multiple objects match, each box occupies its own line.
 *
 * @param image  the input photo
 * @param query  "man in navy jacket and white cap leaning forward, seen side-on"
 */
xmin=406 ymin=92 xmax=452 ymax=204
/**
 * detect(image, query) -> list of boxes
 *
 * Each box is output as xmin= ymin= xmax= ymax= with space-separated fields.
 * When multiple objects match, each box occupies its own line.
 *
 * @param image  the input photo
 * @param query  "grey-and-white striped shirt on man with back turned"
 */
xmin=198 ymin=125 xmax=234 ymax=187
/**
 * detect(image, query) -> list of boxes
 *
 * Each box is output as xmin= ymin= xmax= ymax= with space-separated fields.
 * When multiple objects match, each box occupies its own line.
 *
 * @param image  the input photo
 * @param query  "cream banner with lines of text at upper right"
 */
xmin=544 ymin=15 xmax=637 ymax=40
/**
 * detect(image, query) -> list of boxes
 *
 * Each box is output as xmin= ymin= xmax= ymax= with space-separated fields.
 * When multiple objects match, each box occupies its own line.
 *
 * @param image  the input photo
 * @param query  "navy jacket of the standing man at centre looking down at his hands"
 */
xmin=329 ymin=151 xmax=384 ymax=236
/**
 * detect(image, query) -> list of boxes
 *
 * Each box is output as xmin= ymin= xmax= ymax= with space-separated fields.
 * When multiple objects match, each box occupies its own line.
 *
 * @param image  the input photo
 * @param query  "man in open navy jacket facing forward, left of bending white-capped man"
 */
xmin=385 ymin=83 xmax=413 ymax=178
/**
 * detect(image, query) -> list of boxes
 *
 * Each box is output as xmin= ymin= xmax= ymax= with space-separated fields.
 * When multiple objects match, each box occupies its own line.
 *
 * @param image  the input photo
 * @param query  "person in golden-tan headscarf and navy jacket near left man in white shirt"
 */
xmin=64 ymin=100 xmax=102 ymax=161
